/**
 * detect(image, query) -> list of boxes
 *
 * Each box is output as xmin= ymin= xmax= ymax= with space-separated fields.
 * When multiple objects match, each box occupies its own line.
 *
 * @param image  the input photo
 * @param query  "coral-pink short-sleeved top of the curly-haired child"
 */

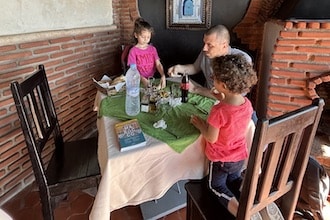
xmin=205 ymin=97 xmax=253 ymax=162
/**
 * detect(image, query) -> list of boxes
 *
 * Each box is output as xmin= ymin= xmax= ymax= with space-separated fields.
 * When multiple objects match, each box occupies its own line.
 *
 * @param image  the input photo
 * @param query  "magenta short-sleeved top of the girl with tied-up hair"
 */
xmin=127 ymin=45 xmax=159 ymax=78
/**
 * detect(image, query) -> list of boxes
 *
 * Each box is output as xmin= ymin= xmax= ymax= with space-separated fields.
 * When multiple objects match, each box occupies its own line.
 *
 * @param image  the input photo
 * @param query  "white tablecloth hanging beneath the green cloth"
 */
xmin=90 ymin=93 xmax=208 ymax=220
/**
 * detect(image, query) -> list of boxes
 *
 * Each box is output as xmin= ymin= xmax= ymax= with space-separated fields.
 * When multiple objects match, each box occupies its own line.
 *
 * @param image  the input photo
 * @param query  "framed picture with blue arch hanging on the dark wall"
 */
xmin=166 ymin=0 xmax=212 ymax=30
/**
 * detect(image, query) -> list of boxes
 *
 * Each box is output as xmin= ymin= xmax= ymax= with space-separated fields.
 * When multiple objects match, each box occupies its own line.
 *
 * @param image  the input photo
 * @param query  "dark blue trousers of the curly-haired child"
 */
xmin=209 ymin=160 xmax=244 ymax=208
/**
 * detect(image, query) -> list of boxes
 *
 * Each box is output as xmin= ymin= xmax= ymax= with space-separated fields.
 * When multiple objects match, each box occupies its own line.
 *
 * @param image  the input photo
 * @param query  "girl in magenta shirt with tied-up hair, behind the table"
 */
xmin=127 ymin=18 xmax=166 ymax=89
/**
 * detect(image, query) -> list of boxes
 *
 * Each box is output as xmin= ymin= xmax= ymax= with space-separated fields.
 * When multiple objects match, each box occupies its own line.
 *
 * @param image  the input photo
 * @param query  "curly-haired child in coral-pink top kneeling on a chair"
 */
xmin=191 ymin=55 xmax=257 ymax=216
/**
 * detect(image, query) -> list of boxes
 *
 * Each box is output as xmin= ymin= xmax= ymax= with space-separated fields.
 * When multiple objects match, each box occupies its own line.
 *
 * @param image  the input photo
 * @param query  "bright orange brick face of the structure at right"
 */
xmin=262 ymin=21 xmax=330 ymax=117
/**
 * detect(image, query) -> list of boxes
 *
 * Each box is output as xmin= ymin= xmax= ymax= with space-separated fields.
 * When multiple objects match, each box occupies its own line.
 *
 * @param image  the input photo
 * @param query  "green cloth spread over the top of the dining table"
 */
xmin=99 ymin=88 xmax=215 ymax=153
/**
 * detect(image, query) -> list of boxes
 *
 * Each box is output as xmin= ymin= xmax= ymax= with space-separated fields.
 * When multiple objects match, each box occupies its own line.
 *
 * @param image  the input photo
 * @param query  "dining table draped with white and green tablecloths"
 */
xmin=89 ymin=82 xmax=254 ymax=220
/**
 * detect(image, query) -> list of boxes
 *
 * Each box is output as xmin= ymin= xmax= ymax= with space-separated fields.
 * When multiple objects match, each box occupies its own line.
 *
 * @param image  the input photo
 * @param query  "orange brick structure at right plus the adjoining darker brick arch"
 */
xmin=234 ymin=0 xmax=330 ymax=118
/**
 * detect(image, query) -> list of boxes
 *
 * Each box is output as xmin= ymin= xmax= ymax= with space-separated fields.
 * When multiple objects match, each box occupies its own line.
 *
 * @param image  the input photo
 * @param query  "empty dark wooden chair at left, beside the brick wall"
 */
xmin=11 ymin=65 xmax=100 ymax=220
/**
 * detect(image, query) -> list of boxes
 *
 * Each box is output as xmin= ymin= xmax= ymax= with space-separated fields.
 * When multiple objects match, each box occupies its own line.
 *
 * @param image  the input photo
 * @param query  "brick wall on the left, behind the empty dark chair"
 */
xmin=0 ymin=0 xmax=138 ymax=205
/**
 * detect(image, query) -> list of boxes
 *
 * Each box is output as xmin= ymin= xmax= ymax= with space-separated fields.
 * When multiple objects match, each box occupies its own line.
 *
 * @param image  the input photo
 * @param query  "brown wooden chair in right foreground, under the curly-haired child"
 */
xmin=185 ymin=99 xmax=324 ymax=220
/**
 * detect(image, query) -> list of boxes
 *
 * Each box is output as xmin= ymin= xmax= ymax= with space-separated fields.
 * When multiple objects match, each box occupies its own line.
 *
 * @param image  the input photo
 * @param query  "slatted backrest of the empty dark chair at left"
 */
xmin=11 ymin=65 xmax=63 ymax=217
